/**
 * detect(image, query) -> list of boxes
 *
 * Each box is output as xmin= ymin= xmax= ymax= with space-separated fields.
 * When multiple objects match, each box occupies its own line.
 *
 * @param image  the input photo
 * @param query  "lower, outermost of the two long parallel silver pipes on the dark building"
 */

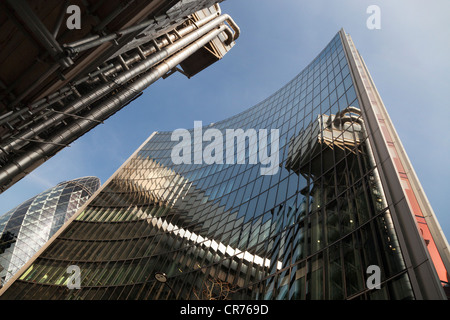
xmin=0 ymin=25 xmax=228 ymax=190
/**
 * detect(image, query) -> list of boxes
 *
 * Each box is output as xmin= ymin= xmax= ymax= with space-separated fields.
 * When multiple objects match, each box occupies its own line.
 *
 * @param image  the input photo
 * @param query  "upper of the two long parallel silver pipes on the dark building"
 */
xmin=0 ymin=15 xmax=229 ymax=152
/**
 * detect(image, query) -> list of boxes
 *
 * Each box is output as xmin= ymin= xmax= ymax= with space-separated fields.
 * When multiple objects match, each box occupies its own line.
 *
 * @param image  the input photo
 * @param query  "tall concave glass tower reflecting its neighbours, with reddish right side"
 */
xmin=1 ymin=30 xmax=450 ymax=300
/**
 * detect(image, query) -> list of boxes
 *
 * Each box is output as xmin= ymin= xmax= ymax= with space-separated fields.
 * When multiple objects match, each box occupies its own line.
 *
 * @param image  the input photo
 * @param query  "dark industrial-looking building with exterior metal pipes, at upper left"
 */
xmin=0 ymin=0 xmax=239 ymax=192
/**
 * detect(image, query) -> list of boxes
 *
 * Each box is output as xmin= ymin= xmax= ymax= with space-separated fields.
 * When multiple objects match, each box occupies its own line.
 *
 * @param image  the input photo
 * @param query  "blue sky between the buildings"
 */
xmin=0 ymin=0 xmax=450 ymax=238
